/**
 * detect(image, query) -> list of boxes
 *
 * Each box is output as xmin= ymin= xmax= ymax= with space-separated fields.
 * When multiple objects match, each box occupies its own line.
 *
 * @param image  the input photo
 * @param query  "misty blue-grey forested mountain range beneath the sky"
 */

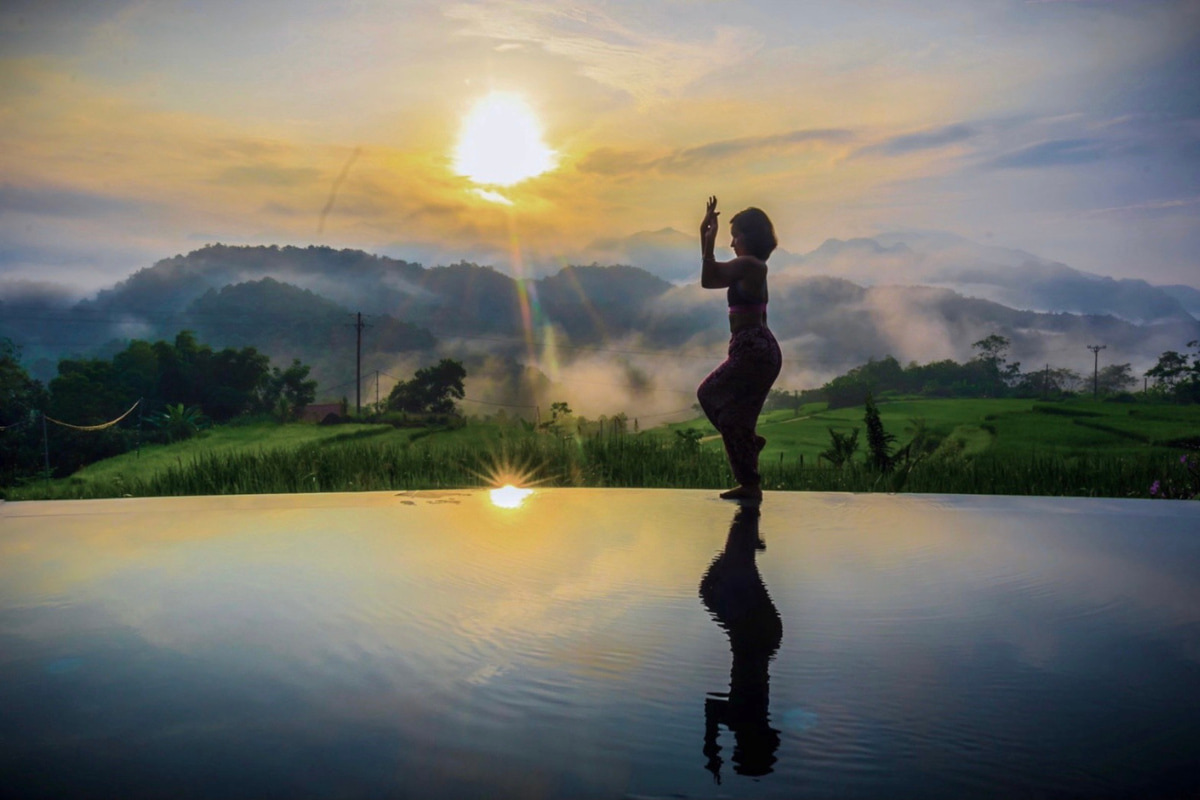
xmin=0 ymin=229 xmax=1200 ymax=414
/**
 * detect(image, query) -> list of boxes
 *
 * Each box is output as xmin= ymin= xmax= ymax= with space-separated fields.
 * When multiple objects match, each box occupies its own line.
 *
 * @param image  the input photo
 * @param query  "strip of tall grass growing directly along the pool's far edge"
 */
xmin=8 ymin=433 xmax=1186 ymax=500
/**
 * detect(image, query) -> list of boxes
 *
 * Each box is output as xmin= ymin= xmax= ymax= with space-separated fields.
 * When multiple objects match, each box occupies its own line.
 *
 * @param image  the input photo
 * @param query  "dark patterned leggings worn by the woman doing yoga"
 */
xmin=696 ymin=327 xmax=784 ymax=486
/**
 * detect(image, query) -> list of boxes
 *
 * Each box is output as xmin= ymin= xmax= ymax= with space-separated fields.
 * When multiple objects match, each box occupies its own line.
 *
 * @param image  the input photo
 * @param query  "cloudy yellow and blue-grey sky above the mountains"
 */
xmin=0 ymin=0 xmax=1200 ymax=291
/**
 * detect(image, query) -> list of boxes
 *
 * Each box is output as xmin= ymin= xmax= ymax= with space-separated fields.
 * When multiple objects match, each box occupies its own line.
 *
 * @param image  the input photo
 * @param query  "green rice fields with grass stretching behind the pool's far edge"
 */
xmin=4 ymin=399 xmax=1200 ymax=500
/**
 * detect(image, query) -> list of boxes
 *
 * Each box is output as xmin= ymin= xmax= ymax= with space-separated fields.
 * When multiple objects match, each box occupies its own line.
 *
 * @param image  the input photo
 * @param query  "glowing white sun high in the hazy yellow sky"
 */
xmin=454 ymin=91 xmax=558 ymax=186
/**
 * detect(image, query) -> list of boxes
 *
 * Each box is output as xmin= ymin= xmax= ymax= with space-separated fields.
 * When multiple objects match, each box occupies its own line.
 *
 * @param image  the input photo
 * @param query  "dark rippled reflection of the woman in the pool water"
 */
xmin=700 ymin=506 xmax=784 ymax=783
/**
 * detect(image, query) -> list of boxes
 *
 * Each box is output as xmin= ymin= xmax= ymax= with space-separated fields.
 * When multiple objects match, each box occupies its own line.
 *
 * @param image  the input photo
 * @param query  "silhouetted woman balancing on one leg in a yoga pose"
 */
xmin=696 ymin=197 xmax=782 ymax=500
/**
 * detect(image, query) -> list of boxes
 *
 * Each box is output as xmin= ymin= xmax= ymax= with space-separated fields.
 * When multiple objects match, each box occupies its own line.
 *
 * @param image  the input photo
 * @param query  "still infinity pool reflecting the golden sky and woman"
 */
xmin=0 ymin=489 xmax=1200 ymax=799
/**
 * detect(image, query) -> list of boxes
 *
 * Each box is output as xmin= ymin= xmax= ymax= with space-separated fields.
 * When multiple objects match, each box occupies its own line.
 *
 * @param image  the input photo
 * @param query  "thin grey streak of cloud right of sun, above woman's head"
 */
xmin=577 ymin=128 xmax=854 ymax=175
